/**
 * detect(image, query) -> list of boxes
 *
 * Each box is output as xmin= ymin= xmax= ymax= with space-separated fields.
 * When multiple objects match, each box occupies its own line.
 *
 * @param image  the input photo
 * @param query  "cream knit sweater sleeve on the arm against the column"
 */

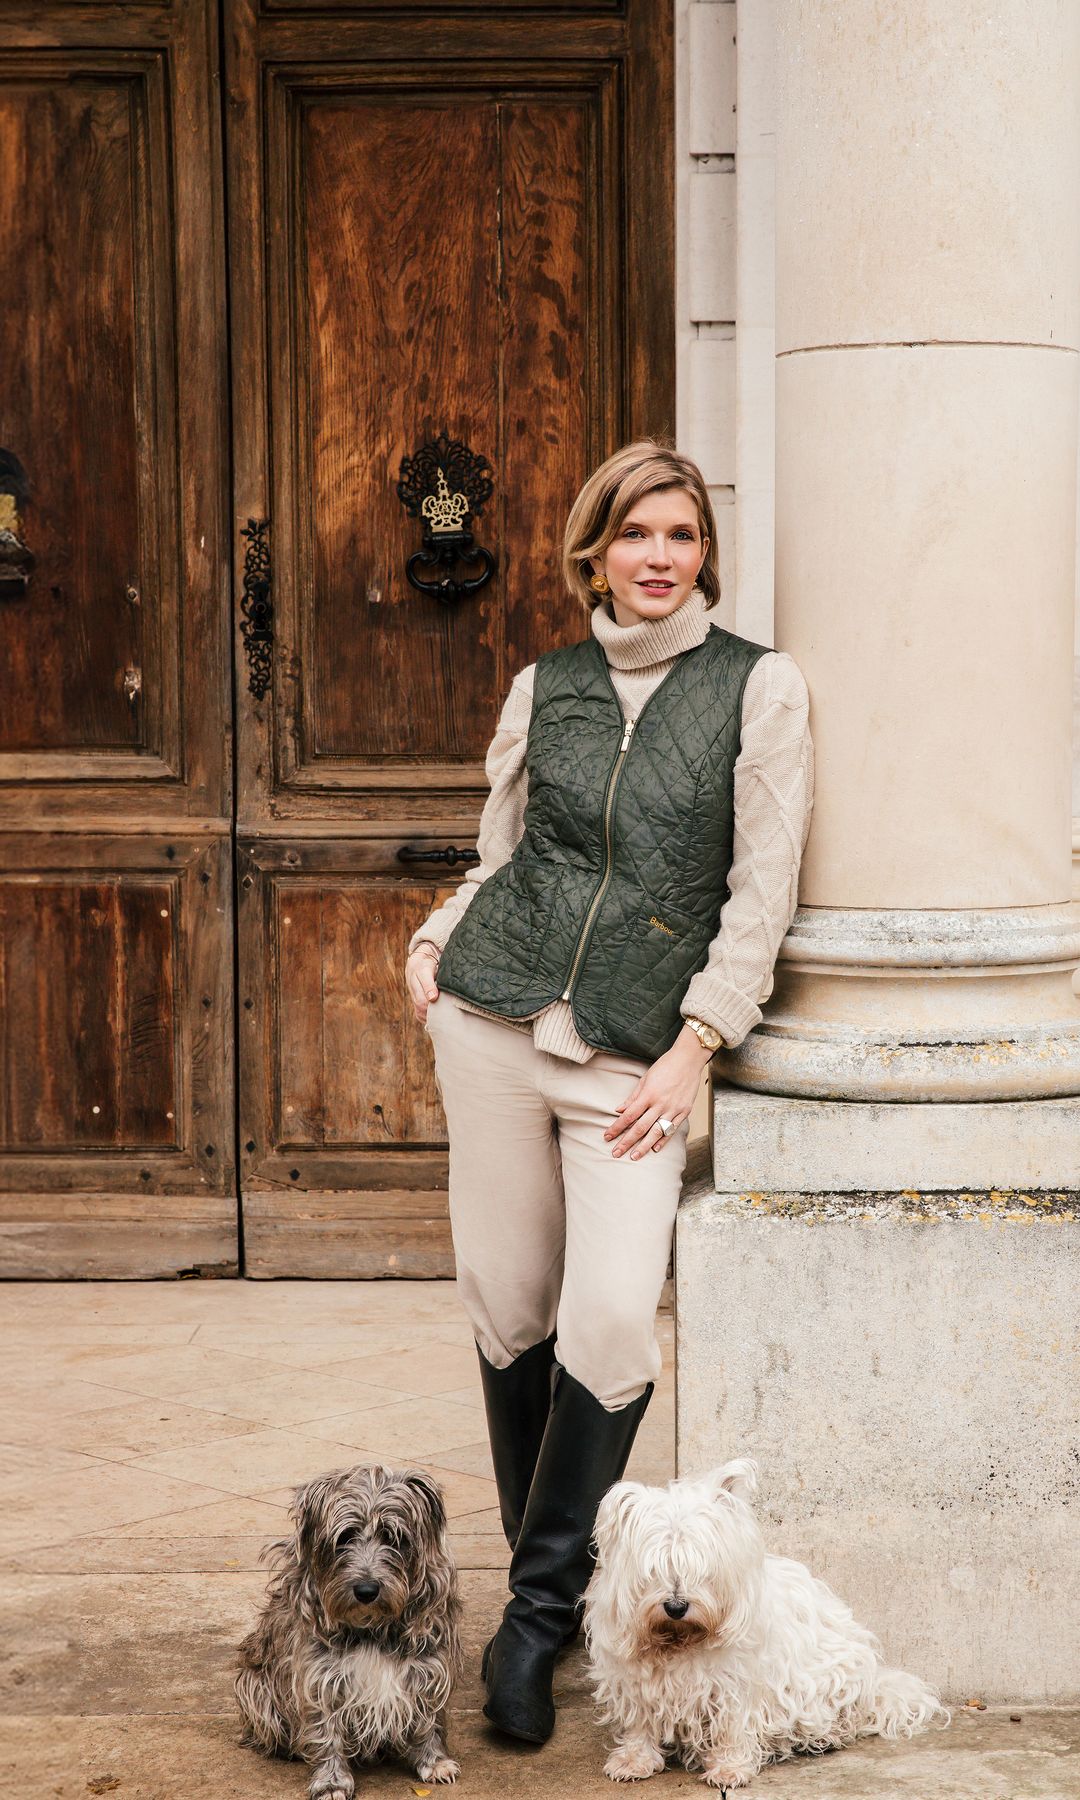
xmin=680 ymin=652 xmax=814 ymax=1048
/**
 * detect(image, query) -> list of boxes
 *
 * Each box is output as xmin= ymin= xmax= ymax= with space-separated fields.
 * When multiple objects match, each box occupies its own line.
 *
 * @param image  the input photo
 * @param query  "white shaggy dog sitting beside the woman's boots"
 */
xmin=585 ymin=1460 xmax=949 ymax=1787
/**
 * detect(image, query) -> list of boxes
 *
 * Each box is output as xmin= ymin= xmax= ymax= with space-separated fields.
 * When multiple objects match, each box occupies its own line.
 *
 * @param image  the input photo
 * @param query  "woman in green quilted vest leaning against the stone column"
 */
xmin=405 ymin=441 xmax=812 ymax=1742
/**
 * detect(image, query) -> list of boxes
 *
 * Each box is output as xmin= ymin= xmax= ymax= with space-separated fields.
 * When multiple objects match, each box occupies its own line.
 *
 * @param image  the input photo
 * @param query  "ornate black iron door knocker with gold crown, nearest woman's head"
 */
xmin=398 ymin=432 xmax=495 ymax=603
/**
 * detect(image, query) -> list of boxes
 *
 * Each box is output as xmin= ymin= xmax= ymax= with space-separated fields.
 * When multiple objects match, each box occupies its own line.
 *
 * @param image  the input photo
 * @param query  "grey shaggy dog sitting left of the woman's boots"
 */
xmin=236 ymin=1463 xmax=461 ymax=1800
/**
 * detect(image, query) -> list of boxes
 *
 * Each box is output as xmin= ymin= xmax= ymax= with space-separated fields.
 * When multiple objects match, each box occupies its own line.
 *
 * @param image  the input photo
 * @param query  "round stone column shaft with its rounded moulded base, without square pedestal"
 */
xmin=724 ymin=0 xmax=1080 ymax=1100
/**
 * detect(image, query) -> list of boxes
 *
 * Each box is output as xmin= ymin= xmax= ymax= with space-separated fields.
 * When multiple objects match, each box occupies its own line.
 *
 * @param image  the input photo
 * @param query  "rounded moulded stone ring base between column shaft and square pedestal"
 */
xmin=716 ymin=902 xmax=1080 ymax=1103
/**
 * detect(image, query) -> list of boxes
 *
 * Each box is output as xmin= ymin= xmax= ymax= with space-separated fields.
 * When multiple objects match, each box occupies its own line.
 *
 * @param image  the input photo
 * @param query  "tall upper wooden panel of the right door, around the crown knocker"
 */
xmin=257 ymin=63 xmax=608 ymax=812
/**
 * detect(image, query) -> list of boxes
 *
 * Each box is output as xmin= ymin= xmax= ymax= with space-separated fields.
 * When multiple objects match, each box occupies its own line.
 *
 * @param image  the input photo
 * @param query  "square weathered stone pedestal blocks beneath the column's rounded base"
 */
xmin=675 ymin=1093 xmax=1080 ymax=1705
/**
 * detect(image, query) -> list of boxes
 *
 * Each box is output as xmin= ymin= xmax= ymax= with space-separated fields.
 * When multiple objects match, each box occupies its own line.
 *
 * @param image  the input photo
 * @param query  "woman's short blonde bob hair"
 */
xmin=563 ymin=437 xmax=720 ymax=612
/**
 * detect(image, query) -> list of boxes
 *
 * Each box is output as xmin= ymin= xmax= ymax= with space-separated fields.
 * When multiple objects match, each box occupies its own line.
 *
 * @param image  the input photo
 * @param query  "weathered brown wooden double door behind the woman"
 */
xmin=0 ymin=0 xmax=675 ymax=1276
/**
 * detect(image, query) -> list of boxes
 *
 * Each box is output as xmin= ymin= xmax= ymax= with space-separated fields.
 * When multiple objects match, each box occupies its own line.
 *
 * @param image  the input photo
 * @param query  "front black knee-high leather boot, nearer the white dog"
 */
xmin=481 ymin=1368 xmax=652 ymax=1744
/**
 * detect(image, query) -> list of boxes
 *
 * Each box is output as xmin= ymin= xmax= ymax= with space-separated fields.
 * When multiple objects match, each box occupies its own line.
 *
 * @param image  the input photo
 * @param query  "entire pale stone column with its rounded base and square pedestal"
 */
xmin=677 ymin=0 xmax=1080 ymax=1699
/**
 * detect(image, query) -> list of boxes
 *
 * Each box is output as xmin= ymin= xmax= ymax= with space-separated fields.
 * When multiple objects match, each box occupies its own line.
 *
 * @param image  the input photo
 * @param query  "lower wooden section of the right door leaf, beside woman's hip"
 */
xmin=239 ymin=839 xmax=450 ymax=1276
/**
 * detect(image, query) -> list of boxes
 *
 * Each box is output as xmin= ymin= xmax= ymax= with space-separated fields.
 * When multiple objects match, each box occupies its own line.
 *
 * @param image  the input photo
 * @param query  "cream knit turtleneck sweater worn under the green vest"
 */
xmin=409 ymin=590 xmax=814 ymax=1062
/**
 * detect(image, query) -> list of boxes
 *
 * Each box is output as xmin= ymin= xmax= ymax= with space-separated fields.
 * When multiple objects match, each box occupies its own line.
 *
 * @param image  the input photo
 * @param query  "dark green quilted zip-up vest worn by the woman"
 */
xmin=437 ymin=625 xmax=767 ymax=1062
